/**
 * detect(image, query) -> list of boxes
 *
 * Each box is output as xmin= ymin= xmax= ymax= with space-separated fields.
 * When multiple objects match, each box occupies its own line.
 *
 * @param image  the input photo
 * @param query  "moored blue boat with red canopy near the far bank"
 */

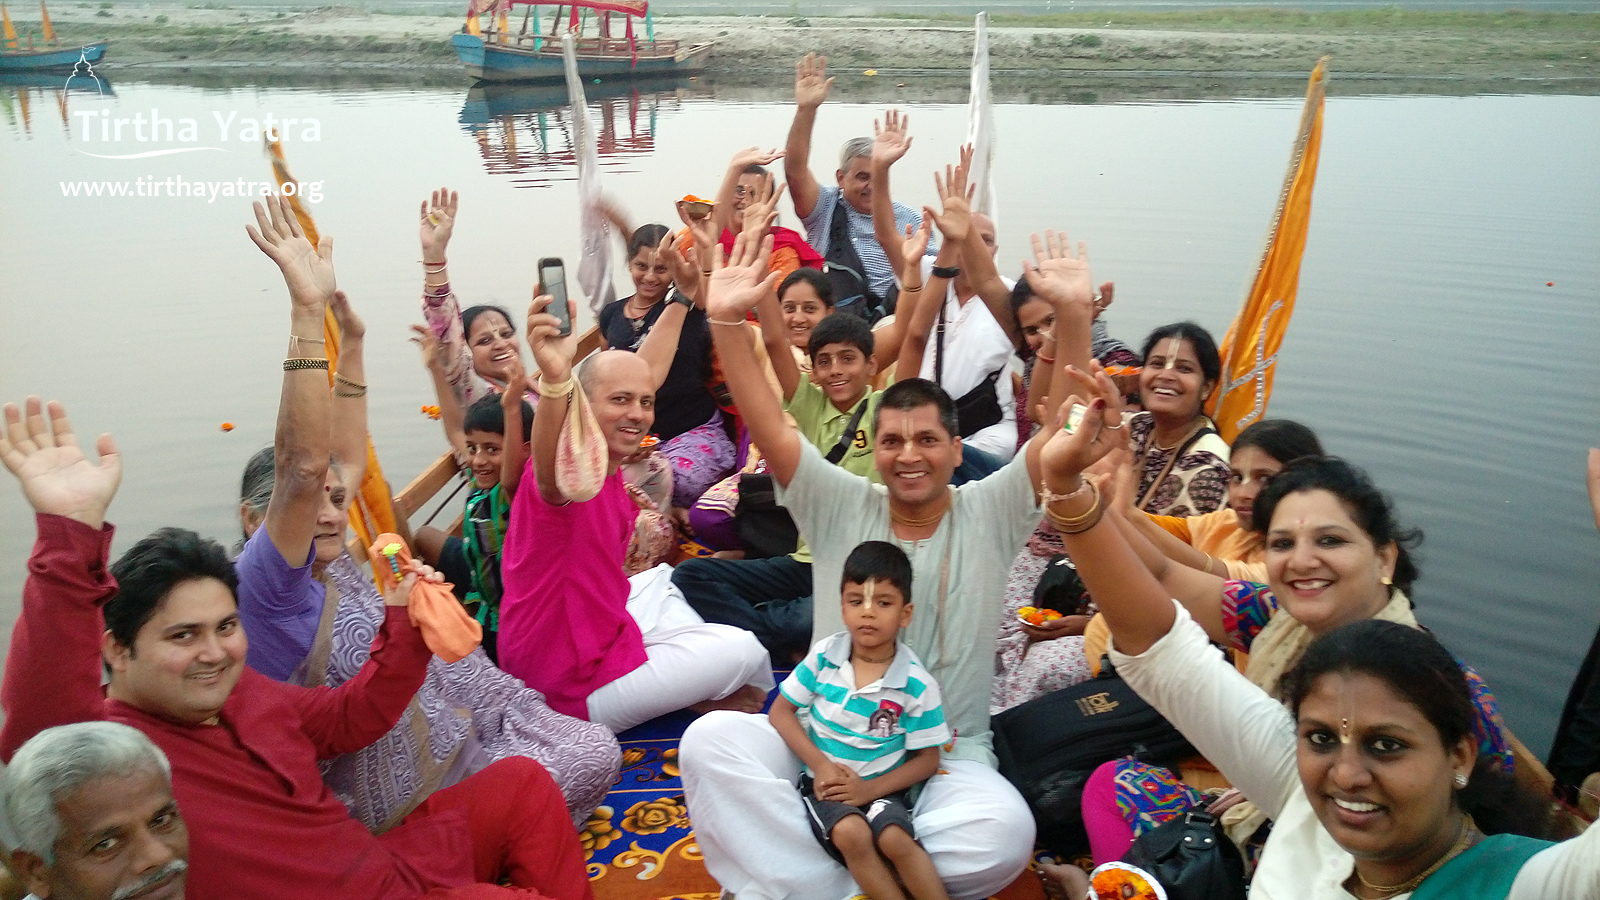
xmin=450 ymin=0 xmax=714 ymax=82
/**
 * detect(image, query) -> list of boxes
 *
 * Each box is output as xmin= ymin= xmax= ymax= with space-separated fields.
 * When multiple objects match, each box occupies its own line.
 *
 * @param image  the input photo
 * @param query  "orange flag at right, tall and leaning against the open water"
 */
xmin=1208 ymin=56 xmax=1328 ymax=442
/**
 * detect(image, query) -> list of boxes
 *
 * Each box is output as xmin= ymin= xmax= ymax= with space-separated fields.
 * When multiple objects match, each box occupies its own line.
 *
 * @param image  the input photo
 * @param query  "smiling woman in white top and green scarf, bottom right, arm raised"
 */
xmin=1042 ymin=365 xmax=1600 ymax=900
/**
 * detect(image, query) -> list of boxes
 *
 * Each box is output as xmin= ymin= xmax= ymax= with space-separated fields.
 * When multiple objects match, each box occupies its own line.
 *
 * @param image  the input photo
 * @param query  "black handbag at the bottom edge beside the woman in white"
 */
xmin=1122 ymin=807 xmax=1245 ymax=900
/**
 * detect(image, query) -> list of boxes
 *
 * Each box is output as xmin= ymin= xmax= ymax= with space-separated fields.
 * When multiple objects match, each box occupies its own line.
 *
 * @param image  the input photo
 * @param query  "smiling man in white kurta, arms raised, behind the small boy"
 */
xmin=680 ymin=222 xmax=1091 ymax=900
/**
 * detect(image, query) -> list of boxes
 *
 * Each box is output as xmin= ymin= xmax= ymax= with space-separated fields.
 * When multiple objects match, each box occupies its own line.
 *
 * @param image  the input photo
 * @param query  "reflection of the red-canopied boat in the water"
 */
xmin=459 ymin=78 xmax=710 ymax=187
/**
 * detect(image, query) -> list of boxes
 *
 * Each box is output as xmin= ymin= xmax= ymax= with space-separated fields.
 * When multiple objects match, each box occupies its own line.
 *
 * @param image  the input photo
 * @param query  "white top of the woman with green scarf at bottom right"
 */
xmin=1110 ymin=601 xmax=1600 ymax=900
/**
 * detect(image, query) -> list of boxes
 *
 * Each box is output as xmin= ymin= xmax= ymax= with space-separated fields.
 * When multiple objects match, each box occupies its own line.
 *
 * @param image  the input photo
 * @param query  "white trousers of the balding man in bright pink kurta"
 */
xmin=589 ymin=565 xmax=773 ymax=732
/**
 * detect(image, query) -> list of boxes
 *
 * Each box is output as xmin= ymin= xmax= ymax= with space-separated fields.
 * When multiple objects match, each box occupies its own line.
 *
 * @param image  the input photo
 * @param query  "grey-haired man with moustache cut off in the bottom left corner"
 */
xmin=0 ymin=722 xmax=189 ymax=900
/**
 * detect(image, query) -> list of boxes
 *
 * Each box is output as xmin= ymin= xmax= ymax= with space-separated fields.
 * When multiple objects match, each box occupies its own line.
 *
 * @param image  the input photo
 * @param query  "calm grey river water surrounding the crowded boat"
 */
xmin=0 ymin=75 xmax=1600 ymax=754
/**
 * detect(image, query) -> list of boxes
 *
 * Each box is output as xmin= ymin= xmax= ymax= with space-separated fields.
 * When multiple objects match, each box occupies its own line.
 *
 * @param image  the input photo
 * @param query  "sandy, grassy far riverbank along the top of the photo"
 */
xmin=18 ymin=2 xmax=1600 ymax=93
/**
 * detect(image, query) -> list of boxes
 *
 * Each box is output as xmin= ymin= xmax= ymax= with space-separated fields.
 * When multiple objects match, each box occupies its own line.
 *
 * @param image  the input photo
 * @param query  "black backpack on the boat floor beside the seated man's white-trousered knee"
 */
xmin=990 ymin=657 xmax=1195 ymax=857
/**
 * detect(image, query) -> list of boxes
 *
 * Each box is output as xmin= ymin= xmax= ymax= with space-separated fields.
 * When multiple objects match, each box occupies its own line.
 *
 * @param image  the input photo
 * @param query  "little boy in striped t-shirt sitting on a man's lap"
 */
xmin=770 ymin=541 xmax=950 ymax=900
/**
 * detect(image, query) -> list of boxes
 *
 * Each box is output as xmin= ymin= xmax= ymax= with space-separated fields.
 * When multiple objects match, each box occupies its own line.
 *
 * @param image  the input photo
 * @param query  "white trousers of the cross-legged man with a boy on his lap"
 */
xmin=678 ymin=713 xmax=1034 ymax=900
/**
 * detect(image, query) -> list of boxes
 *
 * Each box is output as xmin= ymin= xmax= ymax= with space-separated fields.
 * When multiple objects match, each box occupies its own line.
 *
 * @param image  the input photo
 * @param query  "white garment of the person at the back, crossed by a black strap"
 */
xmin=917 ymin=258 xmax=1016 ymax=461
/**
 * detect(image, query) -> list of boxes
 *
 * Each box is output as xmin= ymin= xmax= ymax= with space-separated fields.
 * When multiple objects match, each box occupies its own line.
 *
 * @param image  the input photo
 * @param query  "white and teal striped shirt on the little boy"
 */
xmin=778 ymin=631 xmax=950 ymax=778
